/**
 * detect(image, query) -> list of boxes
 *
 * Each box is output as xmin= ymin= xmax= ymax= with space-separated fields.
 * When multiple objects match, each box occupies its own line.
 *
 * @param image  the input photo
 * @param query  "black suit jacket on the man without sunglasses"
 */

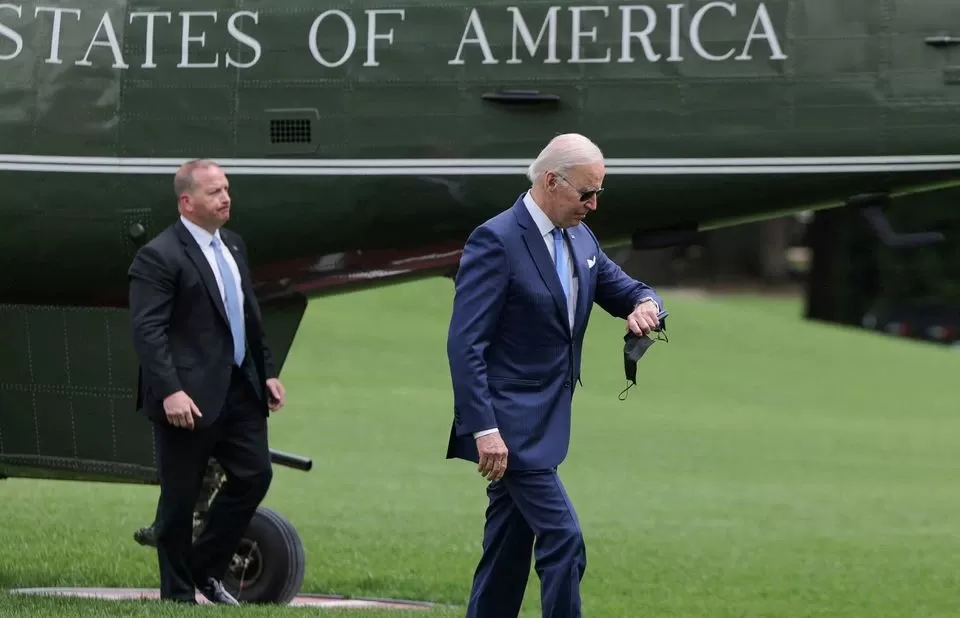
xmin=128 ymin=219 xmax=277 ymax=426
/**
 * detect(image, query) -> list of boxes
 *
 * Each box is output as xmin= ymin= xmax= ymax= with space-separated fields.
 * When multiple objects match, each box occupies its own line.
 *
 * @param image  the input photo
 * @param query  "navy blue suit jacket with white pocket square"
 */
xmin=447 ymin=195 xmax=663 ymax=470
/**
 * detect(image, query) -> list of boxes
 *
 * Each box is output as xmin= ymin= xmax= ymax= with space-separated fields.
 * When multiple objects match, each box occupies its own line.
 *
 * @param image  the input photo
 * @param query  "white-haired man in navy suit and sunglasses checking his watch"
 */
xmin=447 ymin=134 xmax=663 ymax=618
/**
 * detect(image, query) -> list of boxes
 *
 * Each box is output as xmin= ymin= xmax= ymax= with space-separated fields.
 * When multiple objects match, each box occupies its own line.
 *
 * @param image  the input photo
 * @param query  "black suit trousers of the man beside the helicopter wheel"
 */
xmin=154 ymin=367 xmax=273 ymax=601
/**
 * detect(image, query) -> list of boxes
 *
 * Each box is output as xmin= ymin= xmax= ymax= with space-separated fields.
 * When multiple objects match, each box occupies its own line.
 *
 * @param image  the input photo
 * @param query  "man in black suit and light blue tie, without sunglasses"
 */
xmin=128 ymin=160 xmax=285 ymax=605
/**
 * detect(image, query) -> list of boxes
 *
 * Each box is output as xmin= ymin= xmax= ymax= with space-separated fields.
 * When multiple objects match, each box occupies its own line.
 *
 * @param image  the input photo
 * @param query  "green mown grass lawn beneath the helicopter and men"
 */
xmin=0 ymin=280 xmax=960 ymax=618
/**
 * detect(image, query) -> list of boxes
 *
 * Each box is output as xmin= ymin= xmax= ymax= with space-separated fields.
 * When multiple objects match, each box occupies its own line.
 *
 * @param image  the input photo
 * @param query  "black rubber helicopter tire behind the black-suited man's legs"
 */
xmin=223 ymin=506 xmax=306 ymax=605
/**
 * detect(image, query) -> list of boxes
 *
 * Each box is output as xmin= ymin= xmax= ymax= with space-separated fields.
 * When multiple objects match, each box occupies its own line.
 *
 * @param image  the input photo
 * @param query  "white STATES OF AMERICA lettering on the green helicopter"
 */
xmin=0 ymin=2 xmax=787 ymax=69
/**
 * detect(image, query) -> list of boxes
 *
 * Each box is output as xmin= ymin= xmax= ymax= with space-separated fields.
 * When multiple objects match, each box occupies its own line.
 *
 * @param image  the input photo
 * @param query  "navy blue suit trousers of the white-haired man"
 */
xmin=467 ymin=469 xmax=587 ymax=618
